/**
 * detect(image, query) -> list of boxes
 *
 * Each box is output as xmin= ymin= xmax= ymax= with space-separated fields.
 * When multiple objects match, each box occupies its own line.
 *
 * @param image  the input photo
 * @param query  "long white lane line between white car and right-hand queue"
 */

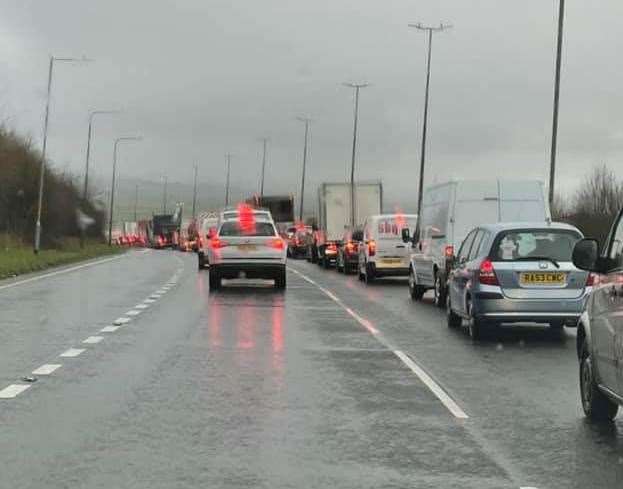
xmin=289 ymin=268 xmax=469 ymax=419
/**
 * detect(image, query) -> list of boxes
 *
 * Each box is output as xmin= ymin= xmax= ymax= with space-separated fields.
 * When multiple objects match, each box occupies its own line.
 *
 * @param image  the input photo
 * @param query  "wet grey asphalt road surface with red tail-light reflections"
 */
xmin=0 ymin=251 xmax=623 ymax=488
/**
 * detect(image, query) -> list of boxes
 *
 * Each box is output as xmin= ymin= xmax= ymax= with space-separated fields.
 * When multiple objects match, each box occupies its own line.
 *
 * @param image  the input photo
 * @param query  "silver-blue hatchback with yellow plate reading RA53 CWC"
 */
xmin=447 ymin=222 xmax=593 ymax=339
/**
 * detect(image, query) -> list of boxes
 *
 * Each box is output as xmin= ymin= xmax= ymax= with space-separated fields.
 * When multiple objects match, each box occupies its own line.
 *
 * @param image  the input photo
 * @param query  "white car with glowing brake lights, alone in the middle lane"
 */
xmin=207 ymin=208 xmax=287 ymax=290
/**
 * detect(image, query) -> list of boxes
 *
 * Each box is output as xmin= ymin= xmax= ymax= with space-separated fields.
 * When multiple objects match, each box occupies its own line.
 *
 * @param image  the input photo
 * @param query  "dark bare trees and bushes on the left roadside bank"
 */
xmin=0 ymin=127 xmax=105 ymax=246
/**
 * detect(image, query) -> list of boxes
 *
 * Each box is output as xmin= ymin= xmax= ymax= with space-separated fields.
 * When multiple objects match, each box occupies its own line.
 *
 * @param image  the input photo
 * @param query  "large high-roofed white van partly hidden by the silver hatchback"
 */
xmin=409 ymin=179 xmax=551 ymax=307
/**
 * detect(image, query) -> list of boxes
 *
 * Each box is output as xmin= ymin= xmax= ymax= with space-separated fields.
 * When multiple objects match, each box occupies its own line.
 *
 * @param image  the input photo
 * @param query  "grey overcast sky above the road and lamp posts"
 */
xmin=0 ymin=0 xmax=623 ymax=207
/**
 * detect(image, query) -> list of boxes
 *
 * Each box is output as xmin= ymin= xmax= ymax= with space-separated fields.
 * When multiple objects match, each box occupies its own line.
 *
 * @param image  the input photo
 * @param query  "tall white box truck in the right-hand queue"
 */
xmin=309 ymin=182 xmax=383 ymax=268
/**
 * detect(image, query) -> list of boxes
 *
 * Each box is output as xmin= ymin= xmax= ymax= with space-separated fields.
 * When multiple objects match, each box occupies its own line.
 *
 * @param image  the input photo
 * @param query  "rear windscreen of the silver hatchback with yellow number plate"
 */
xmin=491 ymin=229 xmax=581 ymax=261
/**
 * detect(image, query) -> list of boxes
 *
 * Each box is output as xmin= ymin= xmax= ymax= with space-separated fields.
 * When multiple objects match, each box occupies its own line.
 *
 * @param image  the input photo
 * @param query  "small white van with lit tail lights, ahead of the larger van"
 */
xmin=359 ymin=214 xmax=417 ymax=283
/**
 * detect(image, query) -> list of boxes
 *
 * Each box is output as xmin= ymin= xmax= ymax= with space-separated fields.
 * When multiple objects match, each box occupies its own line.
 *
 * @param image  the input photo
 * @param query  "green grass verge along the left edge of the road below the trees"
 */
xmin=0 ymin=236 xmax=125 ymax=279
